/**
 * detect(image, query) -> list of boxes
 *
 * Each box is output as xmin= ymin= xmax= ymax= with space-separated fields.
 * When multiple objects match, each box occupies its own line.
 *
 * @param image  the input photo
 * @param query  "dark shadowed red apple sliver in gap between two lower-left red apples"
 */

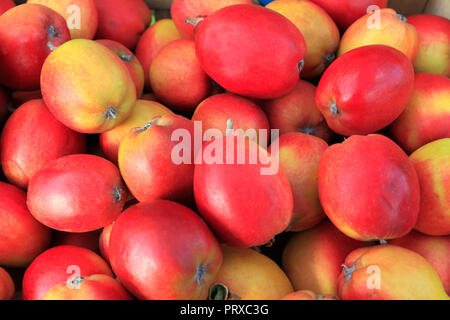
xmin=52 ymin=230 xmax=100 ymax=253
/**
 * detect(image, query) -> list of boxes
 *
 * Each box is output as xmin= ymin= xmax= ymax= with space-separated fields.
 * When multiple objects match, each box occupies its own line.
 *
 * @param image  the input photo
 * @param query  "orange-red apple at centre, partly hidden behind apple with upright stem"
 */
xmin=192 ymin=93 xmax=270 ymax=147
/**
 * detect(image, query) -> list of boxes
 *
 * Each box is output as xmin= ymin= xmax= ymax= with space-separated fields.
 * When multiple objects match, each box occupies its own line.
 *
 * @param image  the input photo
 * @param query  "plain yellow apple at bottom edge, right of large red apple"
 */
xmin=209 ymin=246 xmax=293 ymax=300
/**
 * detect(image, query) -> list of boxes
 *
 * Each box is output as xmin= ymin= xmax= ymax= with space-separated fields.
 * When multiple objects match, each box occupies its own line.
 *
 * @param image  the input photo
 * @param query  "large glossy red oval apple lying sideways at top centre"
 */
xmin=195 ymin=5 xmax=306 ymax=99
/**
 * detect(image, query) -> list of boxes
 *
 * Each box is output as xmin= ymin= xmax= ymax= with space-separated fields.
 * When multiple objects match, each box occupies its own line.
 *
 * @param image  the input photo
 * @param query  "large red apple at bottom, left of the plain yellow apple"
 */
xmin=109 ymin=200 xmax=222 ymax=300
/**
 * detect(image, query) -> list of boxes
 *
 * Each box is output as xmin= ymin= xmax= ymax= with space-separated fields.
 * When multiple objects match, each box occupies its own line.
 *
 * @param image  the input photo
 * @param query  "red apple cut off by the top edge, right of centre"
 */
xmin=310 ymin=0 xmax=388 ymax=31
